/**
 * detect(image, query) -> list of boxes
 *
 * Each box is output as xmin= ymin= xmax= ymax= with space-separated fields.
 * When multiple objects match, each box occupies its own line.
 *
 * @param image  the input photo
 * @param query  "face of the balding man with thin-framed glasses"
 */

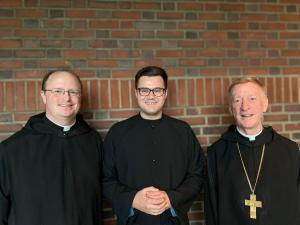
xmin=41 ymin=72 xmax=81 ymax=126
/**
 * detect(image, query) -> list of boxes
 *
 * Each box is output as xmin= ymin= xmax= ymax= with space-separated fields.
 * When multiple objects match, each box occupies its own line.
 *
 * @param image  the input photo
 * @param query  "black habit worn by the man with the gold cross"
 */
xmin=205 ymin=126 xmax=300 ymax=225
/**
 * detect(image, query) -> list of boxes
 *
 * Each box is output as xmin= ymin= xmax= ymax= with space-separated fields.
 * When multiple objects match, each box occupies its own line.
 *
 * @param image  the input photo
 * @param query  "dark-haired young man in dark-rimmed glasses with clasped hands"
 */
xmin=103 ymin=66 xmax=204 ymax=225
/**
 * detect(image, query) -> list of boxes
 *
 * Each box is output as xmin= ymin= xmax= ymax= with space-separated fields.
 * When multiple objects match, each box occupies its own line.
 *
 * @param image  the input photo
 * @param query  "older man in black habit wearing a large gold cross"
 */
xmin=205 ymin=78 xmax=300 ymax=225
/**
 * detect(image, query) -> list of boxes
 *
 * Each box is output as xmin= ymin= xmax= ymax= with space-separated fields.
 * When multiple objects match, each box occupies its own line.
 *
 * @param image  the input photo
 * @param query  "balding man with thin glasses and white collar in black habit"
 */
xmin=0 ymin=70 xmax=102 ymax=225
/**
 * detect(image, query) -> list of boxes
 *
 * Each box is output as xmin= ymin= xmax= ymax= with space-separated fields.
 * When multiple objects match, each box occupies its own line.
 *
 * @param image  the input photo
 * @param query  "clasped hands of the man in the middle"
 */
xmin=132 ymin=187 xmax=171 ymax=215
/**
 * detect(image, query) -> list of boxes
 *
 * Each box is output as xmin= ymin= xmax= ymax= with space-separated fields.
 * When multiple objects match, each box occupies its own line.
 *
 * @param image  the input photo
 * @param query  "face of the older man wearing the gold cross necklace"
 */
xmin=230 ymin=82 xmax=268 ymax=135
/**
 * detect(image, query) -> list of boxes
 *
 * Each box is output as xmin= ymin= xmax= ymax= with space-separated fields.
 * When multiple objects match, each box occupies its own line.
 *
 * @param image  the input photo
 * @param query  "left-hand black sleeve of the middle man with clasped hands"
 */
xmin=103 ymin=128 xmax=137 ymax=224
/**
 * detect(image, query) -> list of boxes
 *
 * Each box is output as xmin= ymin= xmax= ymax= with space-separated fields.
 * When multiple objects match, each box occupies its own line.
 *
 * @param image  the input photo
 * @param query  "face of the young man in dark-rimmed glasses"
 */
xmin=135 ymin=75 xmax=168 ymax=120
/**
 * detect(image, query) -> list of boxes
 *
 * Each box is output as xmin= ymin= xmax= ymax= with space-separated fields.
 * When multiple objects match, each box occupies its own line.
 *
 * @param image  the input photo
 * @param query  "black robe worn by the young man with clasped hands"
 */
xmin=103 ymin=115 xmax=204 ymax=225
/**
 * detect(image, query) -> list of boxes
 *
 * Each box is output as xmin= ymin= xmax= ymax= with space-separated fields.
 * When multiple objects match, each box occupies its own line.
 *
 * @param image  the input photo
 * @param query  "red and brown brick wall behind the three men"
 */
xmin=0 ymin=0 xmax=300 ymax=225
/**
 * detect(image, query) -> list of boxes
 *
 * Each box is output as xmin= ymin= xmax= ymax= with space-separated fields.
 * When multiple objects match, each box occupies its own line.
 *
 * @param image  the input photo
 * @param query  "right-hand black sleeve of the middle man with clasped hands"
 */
xmin=167 ymin=128 xmax=205 ymax=216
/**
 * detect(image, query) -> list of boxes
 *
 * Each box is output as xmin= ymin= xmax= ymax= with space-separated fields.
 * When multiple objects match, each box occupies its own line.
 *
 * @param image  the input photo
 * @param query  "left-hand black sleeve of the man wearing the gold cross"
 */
xmin=204 ymin=147 xmax=218 ymax=225
